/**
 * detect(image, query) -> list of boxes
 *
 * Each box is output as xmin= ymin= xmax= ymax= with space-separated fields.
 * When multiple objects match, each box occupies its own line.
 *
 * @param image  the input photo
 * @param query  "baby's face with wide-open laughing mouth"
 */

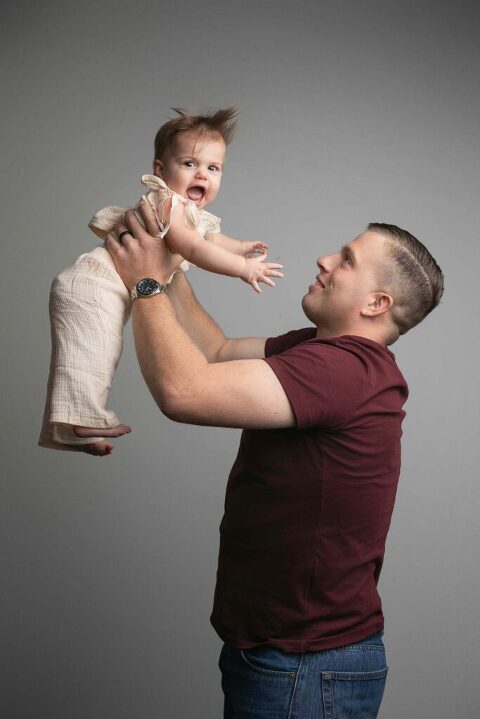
xmin=153 ymin=132 xmax=226 ymax=209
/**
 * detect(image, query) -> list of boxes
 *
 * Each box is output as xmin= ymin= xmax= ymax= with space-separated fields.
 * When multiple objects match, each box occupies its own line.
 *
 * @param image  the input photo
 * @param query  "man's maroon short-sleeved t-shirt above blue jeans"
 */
xmin=211 ymin=328 xmax=408 ymax=652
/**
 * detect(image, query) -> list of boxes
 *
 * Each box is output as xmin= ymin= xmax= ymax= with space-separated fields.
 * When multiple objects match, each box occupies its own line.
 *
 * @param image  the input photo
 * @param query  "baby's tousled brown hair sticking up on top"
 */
xmin=155 ymin=105 xmax=238 ymax=160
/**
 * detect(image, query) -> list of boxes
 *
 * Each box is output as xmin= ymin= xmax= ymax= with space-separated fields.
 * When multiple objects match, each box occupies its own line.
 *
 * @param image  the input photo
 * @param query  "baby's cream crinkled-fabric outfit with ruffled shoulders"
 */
xmin=38 ymin=198 xmax=220 ymax=450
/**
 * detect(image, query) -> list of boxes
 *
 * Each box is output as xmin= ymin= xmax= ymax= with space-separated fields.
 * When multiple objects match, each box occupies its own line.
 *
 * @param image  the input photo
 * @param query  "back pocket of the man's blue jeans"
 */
xmin=322 ymin=667 xmax=388 ymax=719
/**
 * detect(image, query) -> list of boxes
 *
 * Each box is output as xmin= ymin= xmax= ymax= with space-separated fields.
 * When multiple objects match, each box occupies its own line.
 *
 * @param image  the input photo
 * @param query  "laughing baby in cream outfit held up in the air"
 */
xmin=39 ymin=108 xmax=283 ymax=456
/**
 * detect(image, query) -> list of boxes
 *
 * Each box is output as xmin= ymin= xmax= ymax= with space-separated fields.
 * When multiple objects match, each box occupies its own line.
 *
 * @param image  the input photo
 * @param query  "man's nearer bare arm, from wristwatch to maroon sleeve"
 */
xmin=132 ymin=294 xmax=295 ymax=429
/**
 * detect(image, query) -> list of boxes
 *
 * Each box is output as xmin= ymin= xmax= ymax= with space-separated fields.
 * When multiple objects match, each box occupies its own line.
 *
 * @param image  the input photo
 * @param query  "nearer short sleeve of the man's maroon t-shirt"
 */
xmin=265 ymin=340 xmax=368 ymax=429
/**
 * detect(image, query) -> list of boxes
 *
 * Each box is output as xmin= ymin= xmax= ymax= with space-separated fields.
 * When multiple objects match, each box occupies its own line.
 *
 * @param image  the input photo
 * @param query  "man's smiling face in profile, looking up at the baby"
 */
xmin=302 ymin=230 xmax=386 ymax=336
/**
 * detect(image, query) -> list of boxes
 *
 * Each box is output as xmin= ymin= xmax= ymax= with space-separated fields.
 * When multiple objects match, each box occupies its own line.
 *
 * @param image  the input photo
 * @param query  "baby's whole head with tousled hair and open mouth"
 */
xmin=153 ymin=107 xmax=237 ymax=209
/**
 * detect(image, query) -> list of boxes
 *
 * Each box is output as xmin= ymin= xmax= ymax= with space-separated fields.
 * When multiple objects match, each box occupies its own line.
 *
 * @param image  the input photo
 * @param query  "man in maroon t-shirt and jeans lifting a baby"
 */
xmin=100 ymin=206 xmax=443 ymax=719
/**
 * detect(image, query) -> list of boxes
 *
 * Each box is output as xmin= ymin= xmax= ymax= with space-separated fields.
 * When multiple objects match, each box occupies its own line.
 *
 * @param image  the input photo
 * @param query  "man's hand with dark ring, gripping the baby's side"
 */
xmin=105 ymin=201 xmax=183 ymax=290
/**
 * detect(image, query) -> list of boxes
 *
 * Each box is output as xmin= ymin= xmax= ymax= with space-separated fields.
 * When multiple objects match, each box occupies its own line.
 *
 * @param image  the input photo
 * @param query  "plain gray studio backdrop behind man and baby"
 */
xmin=0 ymin=0 xmax=480 ymax=719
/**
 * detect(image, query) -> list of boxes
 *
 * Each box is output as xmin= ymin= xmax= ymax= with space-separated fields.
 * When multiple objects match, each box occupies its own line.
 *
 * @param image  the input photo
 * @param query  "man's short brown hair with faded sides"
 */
xmin=367 ymin=222 xmax=444 ymax=335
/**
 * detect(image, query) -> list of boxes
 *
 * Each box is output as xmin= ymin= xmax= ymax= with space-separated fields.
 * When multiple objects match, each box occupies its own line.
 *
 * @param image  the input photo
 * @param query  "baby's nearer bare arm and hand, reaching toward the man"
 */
xmin=165 ymin=205 xmax=283 ymax=292
